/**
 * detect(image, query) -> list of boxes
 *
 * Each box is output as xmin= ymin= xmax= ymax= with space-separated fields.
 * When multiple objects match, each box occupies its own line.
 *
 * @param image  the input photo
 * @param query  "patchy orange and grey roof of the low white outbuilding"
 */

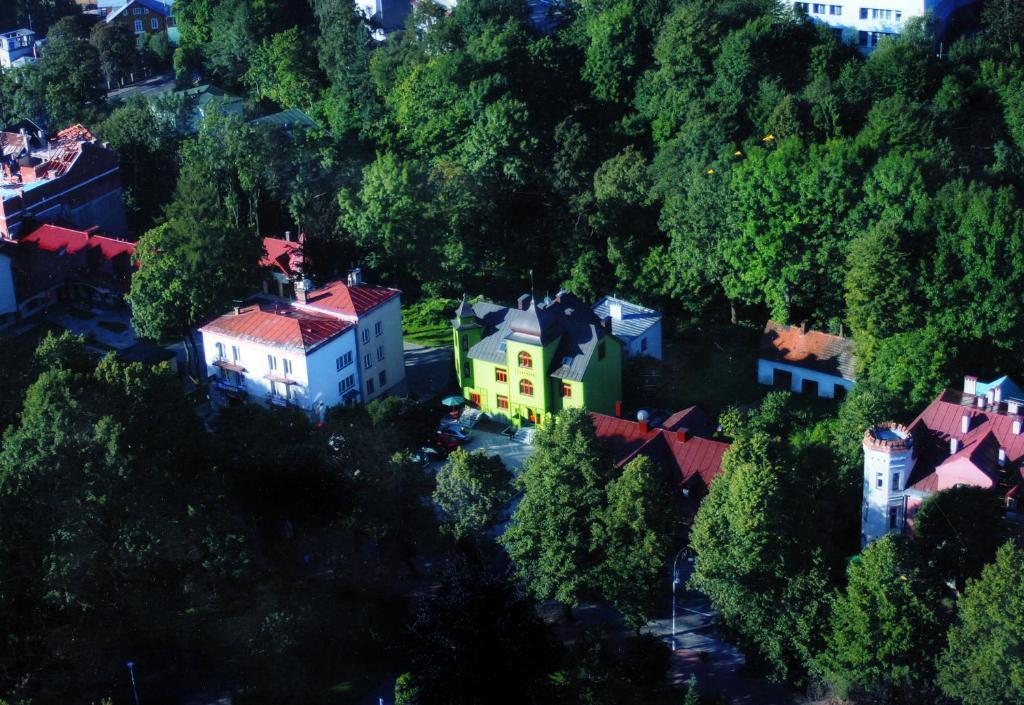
xmin=758 ymin=321 xmax=856 ymax=380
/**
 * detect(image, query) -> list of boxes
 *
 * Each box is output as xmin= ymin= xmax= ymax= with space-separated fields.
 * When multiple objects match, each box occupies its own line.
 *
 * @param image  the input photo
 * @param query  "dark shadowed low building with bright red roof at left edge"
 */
xmin=0 ymin=225 xmax=136 ymax=327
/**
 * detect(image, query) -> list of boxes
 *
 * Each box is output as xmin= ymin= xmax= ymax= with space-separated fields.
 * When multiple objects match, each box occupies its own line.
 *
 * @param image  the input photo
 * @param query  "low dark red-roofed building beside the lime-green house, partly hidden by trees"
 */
xmin=591 ymin=405 xmax=729 ymax=519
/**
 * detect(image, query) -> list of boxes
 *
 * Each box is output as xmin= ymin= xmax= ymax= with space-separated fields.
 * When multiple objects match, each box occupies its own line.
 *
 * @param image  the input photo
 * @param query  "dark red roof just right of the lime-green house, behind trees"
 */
xmin=591 ymin=407 xmax=729 ymax=488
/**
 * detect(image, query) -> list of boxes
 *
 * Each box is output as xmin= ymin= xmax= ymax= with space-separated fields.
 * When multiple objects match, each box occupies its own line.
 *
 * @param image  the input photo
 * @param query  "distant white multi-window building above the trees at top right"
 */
xmin=793 ymin=0 xmax=973 ymax=52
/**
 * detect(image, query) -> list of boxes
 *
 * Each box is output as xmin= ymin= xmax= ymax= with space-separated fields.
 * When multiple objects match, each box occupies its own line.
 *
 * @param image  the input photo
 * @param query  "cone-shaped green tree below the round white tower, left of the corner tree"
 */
xmin=817 ymin=534 xmax=941 ymax=703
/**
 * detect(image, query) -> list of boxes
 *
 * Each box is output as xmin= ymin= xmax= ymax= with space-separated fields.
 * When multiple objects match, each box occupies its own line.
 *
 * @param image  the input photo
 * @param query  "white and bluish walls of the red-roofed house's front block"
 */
xmin=202 ymin=328 xmax=358 ymax=411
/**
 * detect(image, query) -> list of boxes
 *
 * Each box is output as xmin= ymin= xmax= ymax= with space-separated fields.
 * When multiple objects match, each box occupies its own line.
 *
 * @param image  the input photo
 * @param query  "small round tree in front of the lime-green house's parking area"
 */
xmin=434 ymin=449 xmax=512 ymax=539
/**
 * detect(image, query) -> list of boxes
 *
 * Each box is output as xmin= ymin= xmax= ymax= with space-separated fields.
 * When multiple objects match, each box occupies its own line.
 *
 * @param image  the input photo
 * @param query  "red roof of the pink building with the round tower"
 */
xmin=907 ymin=389 xmax=1024 ymax=493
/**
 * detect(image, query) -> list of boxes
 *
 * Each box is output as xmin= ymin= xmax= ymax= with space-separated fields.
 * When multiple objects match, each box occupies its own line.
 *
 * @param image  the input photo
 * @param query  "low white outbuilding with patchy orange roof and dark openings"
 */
xmin=758 ymin=321 xmax=856 ymax=399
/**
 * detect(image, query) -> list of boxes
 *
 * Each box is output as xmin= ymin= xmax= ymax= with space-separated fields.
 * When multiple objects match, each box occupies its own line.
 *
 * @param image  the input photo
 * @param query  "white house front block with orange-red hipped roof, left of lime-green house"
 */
xmin=200 ymin=298 xmax=361 ymax=415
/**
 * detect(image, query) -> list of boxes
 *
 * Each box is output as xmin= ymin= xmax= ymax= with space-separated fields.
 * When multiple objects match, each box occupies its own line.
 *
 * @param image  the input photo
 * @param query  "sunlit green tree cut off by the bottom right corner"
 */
xmin=938 ymin=542 xmax=1024 ymax=705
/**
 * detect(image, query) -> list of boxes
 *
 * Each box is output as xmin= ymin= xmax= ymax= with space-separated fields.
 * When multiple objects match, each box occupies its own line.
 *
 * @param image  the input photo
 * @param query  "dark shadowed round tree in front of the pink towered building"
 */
xmin=913 ymin=486 xmax=1007 ymax=592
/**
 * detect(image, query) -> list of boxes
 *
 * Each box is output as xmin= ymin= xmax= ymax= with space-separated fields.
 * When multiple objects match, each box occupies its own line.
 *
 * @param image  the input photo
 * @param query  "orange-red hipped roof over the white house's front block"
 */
xmin=200 ymin=300 xmax=353 ymax=353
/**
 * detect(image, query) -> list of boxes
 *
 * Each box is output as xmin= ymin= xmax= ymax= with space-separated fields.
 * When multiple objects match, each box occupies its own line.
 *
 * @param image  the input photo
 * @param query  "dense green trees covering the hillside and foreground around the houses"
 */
xmin=0 ymin=0 xmax=1024 ymax=705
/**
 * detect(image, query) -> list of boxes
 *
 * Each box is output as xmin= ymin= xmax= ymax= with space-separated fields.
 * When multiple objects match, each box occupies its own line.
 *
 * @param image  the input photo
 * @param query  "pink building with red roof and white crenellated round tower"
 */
xmin=861 ymin=377 xmax=1024 ymax=544
